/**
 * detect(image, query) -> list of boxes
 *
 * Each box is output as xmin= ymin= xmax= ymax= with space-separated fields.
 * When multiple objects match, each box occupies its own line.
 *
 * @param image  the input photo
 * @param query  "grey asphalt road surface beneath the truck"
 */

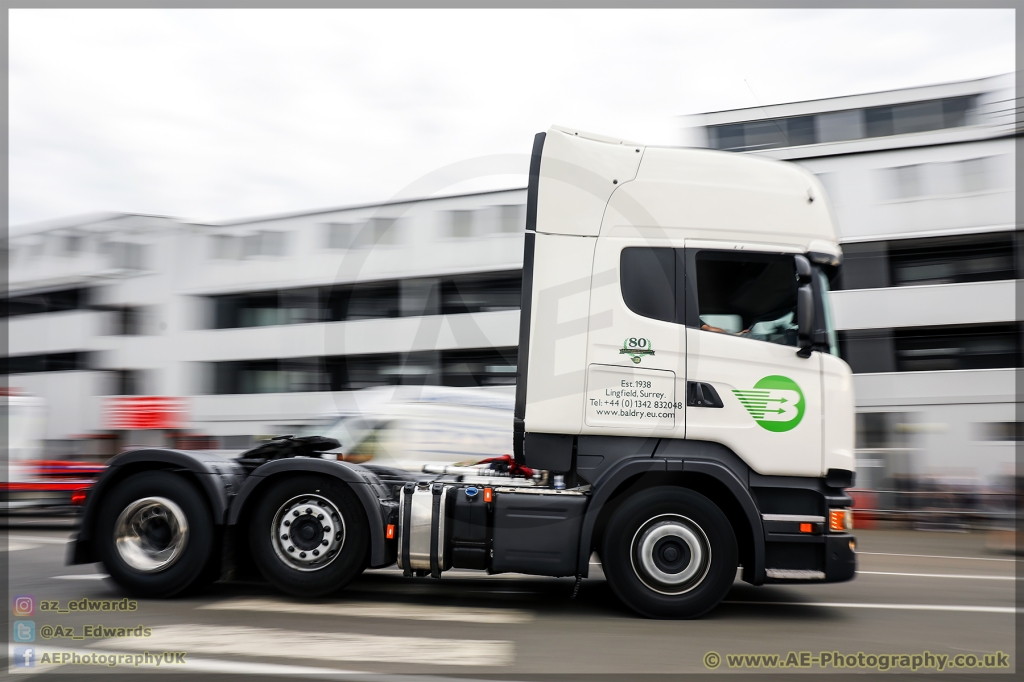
xmin=7 ymin=528 xmax=1017 ymax=679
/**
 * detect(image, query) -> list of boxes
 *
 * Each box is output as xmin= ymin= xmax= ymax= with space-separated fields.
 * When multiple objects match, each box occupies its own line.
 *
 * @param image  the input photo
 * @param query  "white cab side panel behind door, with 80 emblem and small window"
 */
xmin=584 ymin=239 xmax=686 ymax=438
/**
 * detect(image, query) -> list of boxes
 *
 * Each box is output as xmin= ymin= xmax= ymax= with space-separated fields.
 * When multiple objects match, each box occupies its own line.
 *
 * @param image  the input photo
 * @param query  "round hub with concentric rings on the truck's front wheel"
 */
xmin=630 ymin=514 xmax=711 ymax=595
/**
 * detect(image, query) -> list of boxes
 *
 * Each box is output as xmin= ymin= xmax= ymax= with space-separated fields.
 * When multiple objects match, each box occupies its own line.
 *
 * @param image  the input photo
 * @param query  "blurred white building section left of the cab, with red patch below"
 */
xmin=6 ymin=189 xmax=525 ymax=456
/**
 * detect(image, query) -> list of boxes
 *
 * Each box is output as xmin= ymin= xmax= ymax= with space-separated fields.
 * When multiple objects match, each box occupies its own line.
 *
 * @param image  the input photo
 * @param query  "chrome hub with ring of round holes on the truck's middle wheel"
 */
xmin=270 ymin=495 xmax=345 ymax=570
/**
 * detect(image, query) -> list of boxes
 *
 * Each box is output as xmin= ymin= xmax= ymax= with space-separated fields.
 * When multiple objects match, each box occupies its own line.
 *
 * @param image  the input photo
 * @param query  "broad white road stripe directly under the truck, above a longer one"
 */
xmin=199 ymin=599 xmax=534 ymax=624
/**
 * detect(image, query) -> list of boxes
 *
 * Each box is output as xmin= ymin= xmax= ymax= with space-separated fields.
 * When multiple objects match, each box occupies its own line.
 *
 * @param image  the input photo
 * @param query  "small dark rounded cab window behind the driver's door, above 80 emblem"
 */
xmin=618 ymin=247 xmax=682 ymax=322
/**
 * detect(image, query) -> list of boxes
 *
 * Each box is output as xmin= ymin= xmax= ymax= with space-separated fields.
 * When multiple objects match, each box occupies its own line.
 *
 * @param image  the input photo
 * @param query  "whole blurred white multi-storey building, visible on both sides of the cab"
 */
xmin=7 ymin=75 xmax=1022 ymax=488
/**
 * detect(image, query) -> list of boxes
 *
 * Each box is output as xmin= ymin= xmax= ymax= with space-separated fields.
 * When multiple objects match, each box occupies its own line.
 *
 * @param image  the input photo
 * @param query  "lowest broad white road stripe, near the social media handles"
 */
xmin=97 ymin=624 xmax=515 ymax=666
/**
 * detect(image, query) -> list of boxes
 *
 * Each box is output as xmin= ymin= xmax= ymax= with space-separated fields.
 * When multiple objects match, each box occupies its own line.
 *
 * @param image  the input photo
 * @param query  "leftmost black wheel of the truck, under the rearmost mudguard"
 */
xmin=94 ymin=471 xmax=214 ymax=597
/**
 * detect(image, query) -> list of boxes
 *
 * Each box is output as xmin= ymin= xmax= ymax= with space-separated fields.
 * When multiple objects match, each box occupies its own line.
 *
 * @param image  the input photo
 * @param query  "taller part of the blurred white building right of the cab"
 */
xmin=684 ymin=74 xmax=1024 ymax=489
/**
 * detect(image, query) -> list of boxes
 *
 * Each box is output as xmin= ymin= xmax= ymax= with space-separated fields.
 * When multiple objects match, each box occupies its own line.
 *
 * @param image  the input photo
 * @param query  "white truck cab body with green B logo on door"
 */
xmin=517 ymin=128 xmax=853 ymax=476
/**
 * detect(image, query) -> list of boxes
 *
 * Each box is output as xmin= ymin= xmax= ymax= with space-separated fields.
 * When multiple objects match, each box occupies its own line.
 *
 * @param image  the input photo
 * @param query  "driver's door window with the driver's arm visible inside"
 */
xmin=691 ymin=250 xmax=798 ymax=346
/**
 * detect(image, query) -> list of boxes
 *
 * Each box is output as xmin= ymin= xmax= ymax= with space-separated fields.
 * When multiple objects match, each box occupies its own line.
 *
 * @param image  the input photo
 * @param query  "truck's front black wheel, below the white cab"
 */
xmin=601 ymin=486 xmax=737 ymax=619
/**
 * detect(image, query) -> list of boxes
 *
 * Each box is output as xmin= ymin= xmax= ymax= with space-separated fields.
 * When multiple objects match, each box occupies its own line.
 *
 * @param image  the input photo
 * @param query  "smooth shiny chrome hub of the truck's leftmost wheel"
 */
xmin=114 ymin=498 xmax=188 ymax=573
